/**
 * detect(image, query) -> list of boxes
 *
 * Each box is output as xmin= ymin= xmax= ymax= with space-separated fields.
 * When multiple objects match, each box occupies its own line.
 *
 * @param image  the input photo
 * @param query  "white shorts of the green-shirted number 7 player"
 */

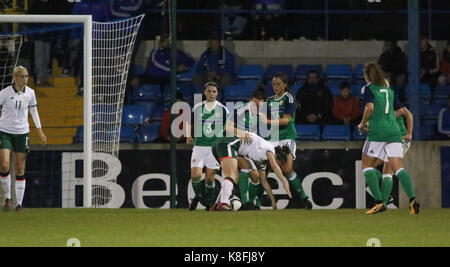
xmin=363 ymin=140 xmax=403 ymax=161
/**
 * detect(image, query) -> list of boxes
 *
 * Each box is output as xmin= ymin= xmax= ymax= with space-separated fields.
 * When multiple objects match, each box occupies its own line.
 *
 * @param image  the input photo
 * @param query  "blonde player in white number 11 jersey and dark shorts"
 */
xmin=0 ymin=66 xmax=47 ymax=211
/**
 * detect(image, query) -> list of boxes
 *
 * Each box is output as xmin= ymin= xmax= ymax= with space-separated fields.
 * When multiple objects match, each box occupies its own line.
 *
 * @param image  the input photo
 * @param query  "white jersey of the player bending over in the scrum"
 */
xmin=238 ymin=133 xmax=275 ymax=168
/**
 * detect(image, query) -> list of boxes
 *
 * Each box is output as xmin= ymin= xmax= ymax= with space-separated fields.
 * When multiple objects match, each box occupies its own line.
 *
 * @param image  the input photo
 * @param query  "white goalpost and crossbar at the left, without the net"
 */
xmin=0 ymin=15 xmax=92 ymax=208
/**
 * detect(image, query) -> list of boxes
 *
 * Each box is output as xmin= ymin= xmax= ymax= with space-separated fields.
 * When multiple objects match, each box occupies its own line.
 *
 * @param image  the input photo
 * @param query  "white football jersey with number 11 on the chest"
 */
xmin=0 ymin=85 xmax=37 ymax=134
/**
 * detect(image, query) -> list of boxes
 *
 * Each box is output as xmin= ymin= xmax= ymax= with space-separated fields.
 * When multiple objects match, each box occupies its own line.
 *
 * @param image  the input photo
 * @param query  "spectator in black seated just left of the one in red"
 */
xmin=296 ymin=70 xmax=333 ymax=124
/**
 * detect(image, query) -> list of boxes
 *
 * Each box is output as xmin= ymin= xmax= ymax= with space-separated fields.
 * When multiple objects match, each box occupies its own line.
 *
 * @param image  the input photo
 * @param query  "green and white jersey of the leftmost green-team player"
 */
xmin=192 ymin=101 xmax=230 ymax=146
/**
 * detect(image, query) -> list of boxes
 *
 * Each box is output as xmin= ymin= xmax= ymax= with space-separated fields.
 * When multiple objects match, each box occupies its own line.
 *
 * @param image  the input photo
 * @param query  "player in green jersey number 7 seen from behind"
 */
xmin=358 ymin=62 xmax=420 ymax=214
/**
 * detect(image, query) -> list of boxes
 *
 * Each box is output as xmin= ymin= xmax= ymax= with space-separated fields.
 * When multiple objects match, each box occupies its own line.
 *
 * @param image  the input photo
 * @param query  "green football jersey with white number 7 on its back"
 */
xmin=363 ymin=83 xmax=402 ymax=142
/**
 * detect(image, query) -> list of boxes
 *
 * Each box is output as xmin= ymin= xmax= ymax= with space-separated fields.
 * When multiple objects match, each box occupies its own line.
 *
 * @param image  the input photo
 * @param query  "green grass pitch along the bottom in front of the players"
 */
xmin=0 ymin=209 xmax=450 ymax=247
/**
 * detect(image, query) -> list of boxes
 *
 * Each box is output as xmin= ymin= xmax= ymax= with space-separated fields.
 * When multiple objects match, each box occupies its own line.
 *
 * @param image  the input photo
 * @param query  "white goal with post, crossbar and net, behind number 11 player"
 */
xmin=0 ymin=15 xmax=144 ymax=208
